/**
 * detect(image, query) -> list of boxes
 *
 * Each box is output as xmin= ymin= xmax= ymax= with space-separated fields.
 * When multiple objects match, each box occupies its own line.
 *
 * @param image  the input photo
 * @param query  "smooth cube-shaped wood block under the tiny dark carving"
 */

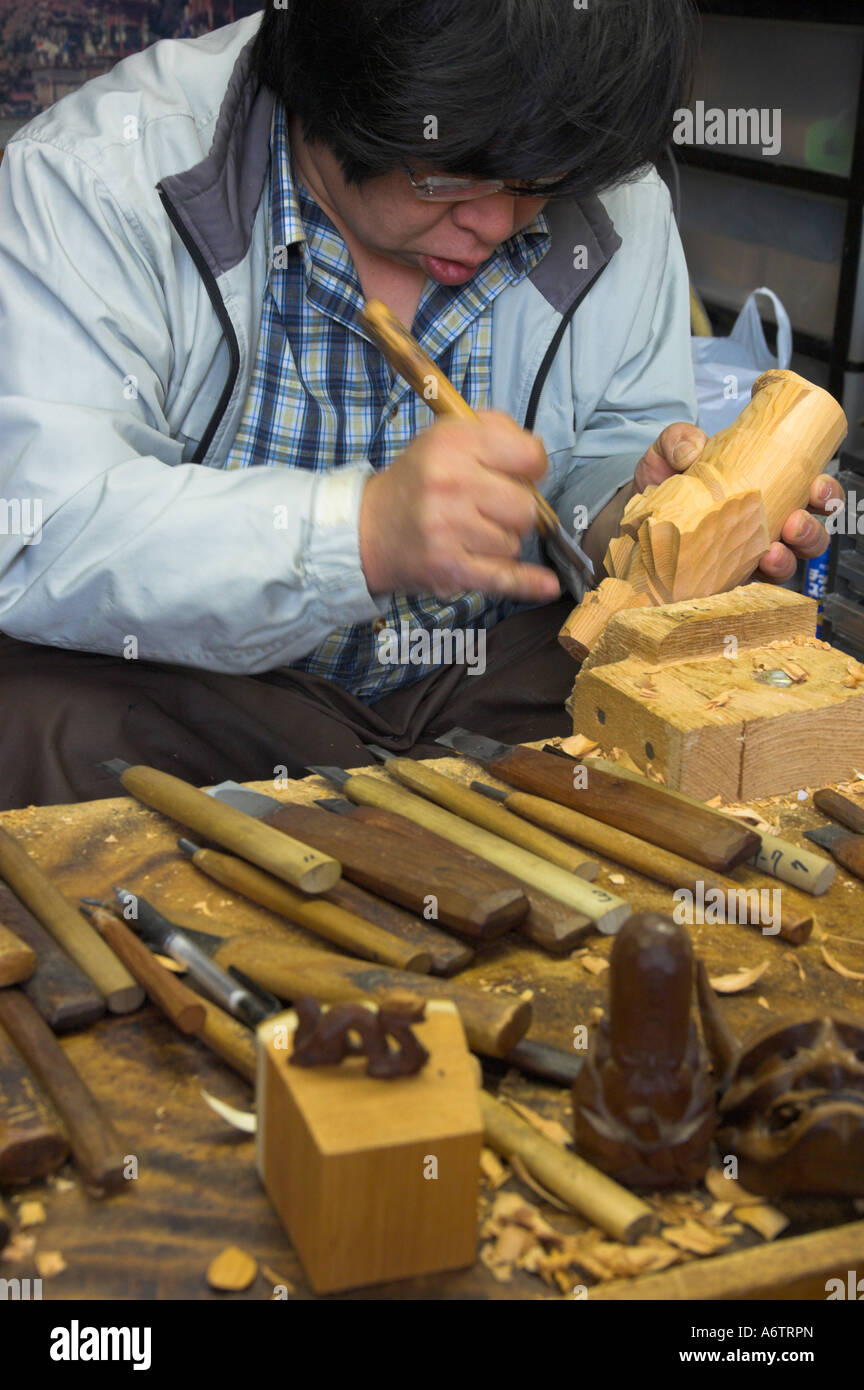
xmin=257 ymin=1001 xmax=483 ymax=1293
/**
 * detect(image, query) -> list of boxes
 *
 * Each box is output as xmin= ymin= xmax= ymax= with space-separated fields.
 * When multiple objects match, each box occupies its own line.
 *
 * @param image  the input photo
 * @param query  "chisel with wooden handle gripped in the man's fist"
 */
xmin=360 ymin=299 xmax=595 ymax=595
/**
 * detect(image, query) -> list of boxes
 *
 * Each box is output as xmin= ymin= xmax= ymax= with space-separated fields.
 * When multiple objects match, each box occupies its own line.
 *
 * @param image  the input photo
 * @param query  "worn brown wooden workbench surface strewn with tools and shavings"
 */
xmin=0 ymin=759 xmax=864 ymax=1301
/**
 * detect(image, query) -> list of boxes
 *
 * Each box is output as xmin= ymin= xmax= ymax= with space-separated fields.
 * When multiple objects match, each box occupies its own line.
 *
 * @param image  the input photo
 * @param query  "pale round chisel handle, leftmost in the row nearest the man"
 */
xmin=119 ymin=767 xmax=342 ymax=892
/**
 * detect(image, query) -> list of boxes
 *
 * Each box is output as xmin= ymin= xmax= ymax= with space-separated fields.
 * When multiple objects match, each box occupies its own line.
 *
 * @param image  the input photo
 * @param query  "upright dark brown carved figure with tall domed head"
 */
xmin=572 ymin=912 xmax=715 ymax=1187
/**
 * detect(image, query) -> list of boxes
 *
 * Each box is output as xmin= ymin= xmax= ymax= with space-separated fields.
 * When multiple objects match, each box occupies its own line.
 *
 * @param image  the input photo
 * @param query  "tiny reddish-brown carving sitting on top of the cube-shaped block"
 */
xmin=289 ymin=992 xmax=429 ymax=1080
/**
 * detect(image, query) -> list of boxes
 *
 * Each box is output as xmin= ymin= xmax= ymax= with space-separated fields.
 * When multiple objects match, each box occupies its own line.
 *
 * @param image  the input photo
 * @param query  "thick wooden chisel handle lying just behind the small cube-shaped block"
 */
xmin=214 ymin=937 xmax=532 ymax=1058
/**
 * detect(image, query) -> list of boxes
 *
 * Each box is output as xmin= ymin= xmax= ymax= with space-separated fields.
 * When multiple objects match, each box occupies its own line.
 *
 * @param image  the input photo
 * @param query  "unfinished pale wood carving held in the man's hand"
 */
xmin=560 ymin=371 xmax=849 ymax=660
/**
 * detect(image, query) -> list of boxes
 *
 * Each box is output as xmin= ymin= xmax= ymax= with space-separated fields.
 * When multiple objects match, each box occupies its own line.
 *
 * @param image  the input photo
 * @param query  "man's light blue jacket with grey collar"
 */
xmin=0 ymin=15 xmax=696 ymax=673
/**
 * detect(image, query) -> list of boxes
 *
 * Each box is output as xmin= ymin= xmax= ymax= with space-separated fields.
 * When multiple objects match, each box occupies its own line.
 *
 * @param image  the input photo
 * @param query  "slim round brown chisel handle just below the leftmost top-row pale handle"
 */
xmin=192 ymin=830 xmax=432 ymax=974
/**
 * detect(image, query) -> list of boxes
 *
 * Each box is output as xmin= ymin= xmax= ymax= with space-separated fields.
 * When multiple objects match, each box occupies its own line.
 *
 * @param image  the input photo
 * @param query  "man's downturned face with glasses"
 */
xmin=292 ymin=127 xmax=545 ymax=285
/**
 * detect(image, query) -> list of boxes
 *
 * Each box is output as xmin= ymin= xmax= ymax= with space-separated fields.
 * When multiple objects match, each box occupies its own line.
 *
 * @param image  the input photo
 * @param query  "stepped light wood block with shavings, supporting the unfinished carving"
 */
xmin=568 ymin=584 xmax=864 ymax=802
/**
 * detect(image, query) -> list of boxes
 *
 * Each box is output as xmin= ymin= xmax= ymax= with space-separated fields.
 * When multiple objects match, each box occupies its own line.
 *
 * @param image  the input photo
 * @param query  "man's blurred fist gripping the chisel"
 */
xmin=360 ymin=410 xmax=561 ymax=602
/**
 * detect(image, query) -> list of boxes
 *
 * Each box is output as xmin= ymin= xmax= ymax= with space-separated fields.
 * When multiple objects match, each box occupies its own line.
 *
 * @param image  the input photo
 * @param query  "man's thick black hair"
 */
xmin=254 ymin=0 xmax=696 ymax=195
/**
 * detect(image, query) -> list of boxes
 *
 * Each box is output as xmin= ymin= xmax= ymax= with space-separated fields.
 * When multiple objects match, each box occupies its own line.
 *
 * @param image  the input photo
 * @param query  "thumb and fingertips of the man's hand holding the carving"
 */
xmin=635 ymin=424 xmax=845 ymax=584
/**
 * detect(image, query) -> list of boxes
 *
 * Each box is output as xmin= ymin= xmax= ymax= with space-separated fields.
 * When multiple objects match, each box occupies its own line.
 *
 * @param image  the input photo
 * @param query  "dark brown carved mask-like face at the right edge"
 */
xmin=699 ymin=962 xmax=864 ymax=1197
